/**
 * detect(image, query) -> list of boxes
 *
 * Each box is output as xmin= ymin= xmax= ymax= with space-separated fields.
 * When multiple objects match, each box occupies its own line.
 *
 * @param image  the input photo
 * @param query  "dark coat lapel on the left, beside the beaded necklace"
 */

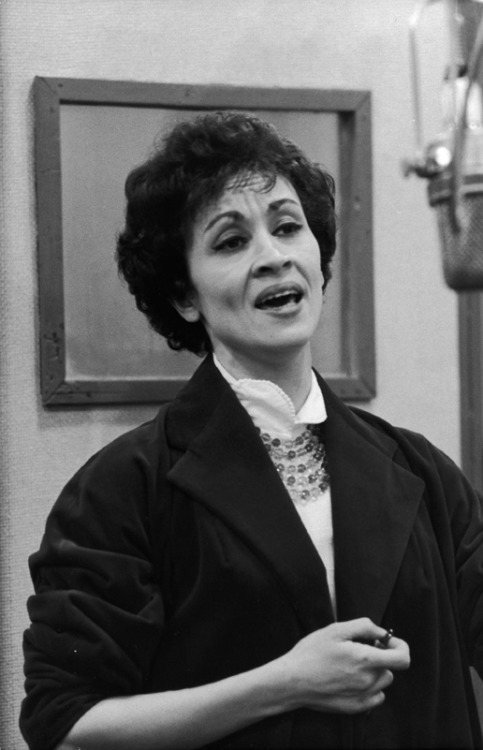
xmin=167 ymin=360 xmax=334 ymax=632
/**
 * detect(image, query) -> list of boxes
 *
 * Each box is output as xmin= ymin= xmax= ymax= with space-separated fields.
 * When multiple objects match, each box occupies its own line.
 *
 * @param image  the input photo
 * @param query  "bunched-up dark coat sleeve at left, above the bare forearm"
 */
xmin=20 ymin=426 xmax=168 ymax=750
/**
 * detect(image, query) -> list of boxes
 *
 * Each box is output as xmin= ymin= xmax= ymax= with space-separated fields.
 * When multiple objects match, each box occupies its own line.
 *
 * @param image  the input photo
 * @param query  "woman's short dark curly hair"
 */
xmin=116 ymin=112 xmax=336 ymax=355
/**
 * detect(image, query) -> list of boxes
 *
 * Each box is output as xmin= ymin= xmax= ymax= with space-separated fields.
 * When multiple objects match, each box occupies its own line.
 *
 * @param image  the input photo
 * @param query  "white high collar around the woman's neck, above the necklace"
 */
xmin=213 ymin=355 xmax=327 ymax=439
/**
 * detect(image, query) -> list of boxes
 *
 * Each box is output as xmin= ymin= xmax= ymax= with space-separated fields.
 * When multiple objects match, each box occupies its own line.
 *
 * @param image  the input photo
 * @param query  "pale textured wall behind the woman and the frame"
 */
xmin=0 ymin=0 xmax=466 ymax=750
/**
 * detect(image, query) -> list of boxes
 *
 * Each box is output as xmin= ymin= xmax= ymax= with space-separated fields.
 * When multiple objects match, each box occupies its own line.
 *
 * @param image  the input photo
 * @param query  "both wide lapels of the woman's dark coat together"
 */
xmin=166 ymin=358 xmax=422 ymax=632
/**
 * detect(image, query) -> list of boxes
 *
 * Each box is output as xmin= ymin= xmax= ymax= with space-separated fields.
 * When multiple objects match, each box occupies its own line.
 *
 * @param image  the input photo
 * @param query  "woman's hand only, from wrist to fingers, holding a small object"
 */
xmin=279 ymin=618 xmax=410 ymax=713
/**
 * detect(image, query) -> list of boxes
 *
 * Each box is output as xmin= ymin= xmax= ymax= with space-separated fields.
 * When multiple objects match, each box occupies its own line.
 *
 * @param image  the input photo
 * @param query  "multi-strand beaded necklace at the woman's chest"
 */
xmin=259 ymin=424 xmax=330 ymax=505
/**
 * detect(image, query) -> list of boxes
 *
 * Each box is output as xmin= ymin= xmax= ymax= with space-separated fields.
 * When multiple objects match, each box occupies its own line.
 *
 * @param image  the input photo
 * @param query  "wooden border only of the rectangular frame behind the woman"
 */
xmin=34 ymin=78 xmax=375 ymax=406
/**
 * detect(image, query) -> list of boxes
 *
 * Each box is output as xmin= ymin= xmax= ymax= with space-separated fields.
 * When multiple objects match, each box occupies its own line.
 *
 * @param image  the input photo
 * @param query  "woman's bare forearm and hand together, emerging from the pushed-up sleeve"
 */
xmin=57 ymin=619 xmax=409 ymax=750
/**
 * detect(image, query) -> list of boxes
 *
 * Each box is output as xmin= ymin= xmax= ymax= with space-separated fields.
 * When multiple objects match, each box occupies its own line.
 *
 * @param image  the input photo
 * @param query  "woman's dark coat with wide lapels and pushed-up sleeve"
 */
xmin=21 ymin=358 xmax=483 ymax=750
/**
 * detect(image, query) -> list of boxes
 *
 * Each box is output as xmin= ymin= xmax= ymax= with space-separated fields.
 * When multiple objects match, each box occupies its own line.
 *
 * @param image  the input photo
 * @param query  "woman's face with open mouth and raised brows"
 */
xmin=178 ymin=175 xmax=324 ymax=376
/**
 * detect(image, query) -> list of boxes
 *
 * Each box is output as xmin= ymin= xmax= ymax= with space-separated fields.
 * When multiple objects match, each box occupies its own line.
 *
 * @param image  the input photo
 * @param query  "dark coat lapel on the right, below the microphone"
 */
xmin=321 ymin=381 xmax=424 ymax=626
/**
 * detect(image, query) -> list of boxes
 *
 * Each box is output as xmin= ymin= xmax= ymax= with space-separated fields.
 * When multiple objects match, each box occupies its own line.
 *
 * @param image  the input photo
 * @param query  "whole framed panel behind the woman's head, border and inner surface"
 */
xmin=33 ymin=77 xmax=376 ymax=407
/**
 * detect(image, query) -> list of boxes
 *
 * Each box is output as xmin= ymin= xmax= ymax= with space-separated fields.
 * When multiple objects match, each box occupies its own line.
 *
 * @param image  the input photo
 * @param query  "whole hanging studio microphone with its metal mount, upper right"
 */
xmin=403 ymin=0 xmax=483 ymax=291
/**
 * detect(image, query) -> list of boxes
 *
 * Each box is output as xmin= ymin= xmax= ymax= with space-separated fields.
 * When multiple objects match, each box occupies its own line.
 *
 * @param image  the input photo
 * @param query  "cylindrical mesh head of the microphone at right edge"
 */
xmin=428 ymin=169 xmax=483 ymax=291
